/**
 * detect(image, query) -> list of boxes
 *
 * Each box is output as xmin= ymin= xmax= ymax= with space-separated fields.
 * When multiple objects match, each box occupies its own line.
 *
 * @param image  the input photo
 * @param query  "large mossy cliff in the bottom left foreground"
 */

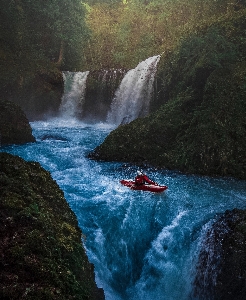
xmin=0 ymin=153 xmax=104 ymax=300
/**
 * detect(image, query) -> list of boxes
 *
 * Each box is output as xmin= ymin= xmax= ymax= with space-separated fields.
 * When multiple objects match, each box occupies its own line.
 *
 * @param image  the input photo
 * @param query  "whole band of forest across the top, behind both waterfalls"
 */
xmin=0 ymin=0 xmax=246 ymax=91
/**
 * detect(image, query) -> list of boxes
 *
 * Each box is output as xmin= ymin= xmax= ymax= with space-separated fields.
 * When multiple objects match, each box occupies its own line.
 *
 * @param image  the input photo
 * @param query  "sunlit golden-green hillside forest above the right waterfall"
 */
xmin=84 ymin=0 xmax=246 ymax=69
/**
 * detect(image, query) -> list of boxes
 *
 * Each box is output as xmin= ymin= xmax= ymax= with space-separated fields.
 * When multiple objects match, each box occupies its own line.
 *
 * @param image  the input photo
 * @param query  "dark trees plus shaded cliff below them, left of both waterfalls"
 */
xmin=0 ymin=0 xmax=89 ymax=119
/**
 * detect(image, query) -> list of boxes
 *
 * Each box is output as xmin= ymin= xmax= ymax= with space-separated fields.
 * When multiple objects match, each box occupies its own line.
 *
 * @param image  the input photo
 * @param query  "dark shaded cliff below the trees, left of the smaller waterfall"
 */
xmin=0 ymin=65 xmax=64 ymax=121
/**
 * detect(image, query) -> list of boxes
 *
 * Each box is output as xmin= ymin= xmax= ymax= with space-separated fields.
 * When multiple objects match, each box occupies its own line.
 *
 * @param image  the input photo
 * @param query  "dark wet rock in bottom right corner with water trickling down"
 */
xmin=194 ymin=209 xmax=246 ymax=300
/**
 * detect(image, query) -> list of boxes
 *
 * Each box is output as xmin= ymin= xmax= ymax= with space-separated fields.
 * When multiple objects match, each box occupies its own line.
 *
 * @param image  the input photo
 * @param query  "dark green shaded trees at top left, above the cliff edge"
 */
xmin=0 ymin=0 xmax=88 ymax=85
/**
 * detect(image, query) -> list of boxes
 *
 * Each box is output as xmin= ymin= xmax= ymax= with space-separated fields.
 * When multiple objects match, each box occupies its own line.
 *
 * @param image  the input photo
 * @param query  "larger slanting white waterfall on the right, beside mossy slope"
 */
xmin=107 ymin=55 xmax=160 ymax=125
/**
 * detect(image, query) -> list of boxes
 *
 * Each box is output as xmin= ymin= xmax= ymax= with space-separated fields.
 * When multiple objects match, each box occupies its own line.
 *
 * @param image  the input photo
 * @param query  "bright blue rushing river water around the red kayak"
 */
xmin=1 ymin=119 xmax=246 ymax=300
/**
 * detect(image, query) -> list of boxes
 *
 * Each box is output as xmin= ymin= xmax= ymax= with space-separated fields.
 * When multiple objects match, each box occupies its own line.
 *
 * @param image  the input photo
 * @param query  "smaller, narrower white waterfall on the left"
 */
xmin=59 ymin=71 xmax=89 ymax=119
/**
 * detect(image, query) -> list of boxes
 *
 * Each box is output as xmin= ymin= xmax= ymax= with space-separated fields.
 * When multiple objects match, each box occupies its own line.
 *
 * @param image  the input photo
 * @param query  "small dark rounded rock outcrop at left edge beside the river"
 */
xmin=0 ymin=100 xmax=35 ymax=146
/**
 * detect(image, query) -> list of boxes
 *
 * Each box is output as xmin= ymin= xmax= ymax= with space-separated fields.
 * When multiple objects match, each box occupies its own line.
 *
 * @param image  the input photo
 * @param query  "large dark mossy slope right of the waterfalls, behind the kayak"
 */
xmin=92 ymin=12 xmax=246 ymax=179
